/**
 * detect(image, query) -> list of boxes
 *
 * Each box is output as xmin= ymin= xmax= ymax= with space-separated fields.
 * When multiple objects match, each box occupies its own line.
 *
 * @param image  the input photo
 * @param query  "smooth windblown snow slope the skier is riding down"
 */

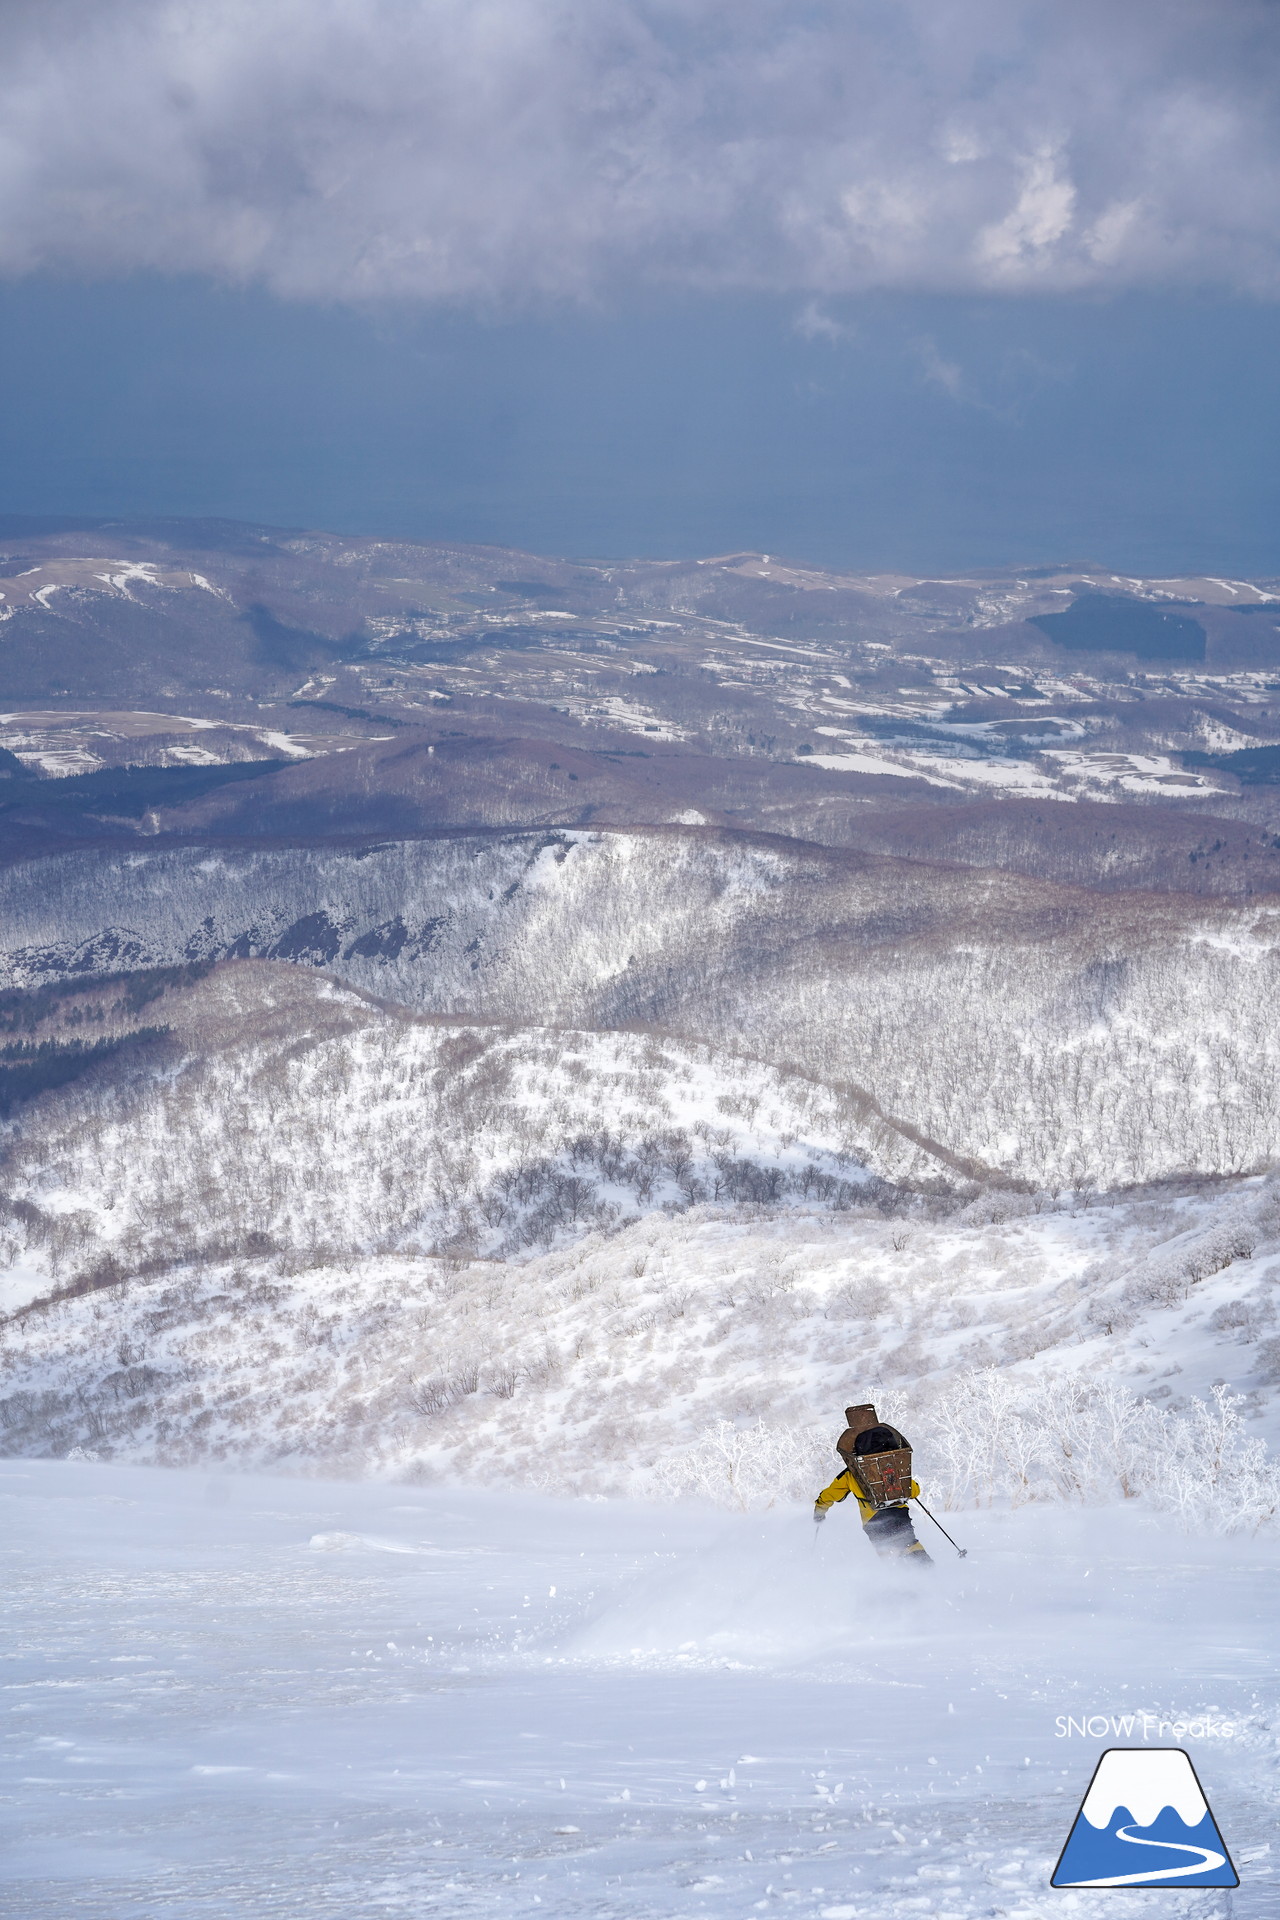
xmin=0 ymin=1455 xmax=1280 ymax=1920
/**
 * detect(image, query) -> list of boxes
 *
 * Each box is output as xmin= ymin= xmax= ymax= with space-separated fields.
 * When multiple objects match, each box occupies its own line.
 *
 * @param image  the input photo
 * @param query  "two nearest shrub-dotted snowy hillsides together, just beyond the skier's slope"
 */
xmin=0 ymin=960 xmax=1280 ymax=1490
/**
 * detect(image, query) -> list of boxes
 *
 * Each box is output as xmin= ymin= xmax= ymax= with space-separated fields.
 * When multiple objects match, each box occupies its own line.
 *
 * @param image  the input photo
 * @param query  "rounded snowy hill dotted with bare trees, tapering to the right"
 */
xmin=0 ymin=962 xmax=932 ymax=1306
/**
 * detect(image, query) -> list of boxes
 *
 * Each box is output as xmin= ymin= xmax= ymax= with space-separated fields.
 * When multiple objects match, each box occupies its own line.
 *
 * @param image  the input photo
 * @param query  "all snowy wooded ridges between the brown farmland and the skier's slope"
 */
xmin=0 ymin=831 xmax=1280 ymax=1488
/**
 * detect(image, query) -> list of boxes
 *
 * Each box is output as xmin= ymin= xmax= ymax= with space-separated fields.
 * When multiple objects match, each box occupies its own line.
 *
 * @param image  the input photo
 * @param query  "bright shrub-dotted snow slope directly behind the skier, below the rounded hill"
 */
xmin=10 ymin=1181 xmax=1280 ymax=1497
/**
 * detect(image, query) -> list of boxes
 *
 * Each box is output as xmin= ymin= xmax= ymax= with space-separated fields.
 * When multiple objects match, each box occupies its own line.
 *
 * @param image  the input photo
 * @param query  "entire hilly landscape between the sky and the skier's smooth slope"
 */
xmin=0 ymin=522 xmax=1280 ymax=1511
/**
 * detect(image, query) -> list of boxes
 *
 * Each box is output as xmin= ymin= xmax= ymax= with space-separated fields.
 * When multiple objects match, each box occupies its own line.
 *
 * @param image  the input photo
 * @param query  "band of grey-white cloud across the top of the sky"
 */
xmin=0 ymin=0 xmax=1280 ymax=313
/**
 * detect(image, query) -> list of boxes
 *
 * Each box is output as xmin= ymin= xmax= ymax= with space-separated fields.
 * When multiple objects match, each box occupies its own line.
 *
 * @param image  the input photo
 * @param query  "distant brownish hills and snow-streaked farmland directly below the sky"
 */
xmin=0 ymin=520 xmax=1280 ymax=899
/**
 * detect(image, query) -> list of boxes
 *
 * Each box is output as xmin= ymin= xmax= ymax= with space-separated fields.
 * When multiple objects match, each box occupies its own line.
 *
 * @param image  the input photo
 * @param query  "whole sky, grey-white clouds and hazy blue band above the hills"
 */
xmin=0 ymin=0 xmax=1280 ymax=572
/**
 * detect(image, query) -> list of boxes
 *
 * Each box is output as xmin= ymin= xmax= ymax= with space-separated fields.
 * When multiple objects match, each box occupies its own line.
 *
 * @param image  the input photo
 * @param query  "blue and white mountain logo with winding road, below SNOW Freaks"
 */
xmin=1050 ymin=1747 xmax=1240 ymax=1887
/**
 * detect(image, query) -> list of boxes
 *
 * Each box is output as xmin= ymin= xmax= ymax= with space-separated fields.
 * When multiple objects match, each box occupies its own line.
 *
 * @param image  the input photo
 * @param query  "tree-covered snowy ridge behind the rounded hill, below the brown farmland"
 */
xmin=0 ymin=829 xmax=1280 ymax=1188
